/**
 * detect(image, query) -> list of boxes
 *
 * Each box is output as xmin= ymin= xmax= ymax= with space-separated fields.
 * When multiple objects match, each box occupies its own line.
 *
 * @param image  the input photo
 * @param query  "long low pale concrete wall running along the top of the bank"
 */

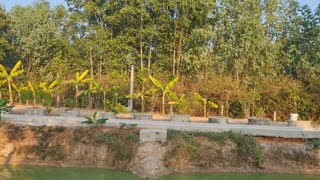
xmin=2 ymin=114 xmax=320 ymax=138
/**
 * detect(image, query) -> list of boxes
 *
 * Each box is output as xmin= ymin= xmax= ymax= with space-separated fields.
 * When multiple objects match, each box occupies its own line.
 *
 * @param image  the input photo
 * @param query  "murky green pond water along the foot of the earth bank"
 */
xmin=0 ymin=166 xmax=320 ymax=180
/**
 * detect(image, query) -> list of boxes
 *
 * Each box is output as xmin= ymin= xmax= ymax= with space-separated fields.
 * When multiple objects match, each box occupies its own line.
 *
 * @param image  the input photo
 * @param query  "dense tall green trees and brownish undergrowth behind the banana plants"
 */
xmin=0 ymin=0 xmax=320 ymax=120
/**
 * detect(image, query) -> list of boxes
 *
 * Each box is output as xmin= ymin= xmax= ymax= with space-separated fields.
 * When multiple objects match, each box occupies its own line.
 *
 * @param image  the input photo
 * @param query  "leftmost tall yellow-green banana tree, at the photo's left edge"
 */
xmin=0 ymin=61 xmax=24 ymax=103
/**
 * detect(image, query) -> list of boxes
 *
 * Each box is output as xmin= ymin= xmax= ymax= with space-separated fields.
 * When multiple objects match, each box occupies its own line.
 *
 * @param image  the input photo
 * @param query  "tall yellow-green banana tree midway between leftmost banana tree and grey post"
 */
xmin=68 ymin=70 xmax=92 ymax=106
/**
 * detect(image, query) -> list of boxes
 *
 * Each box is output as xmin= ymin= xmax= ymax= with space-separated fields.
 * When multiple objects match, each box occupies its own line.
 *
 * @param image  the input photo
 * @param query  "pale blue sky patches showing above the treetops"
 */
xmin=0 ymin=0 xmax=320 ymax=10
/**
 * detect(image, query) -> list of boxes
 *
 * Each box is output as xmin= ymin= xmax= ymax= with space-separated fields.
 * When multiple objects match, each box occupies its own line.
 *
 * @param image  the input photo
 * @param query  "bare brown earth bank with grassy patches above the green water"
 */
xmin=0 ymin=123 xmax=320 ymax=178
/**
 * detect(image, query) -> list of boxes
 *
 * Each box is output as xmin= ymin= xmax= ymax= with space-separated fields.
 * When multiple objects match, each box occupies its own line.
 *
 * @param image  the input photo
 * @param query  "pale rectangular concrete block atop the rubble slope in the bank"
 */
xmin=140 ymin=129 xmax=167 ymax=143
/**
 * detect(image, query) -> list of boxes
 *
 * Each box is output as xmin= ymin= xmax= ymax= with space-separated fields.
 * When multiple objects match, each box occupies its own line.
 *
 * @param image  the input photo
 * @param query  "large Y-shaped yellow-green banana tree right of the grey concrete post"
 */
xmin=149 ymin=75 xmax=179 ymax=114
